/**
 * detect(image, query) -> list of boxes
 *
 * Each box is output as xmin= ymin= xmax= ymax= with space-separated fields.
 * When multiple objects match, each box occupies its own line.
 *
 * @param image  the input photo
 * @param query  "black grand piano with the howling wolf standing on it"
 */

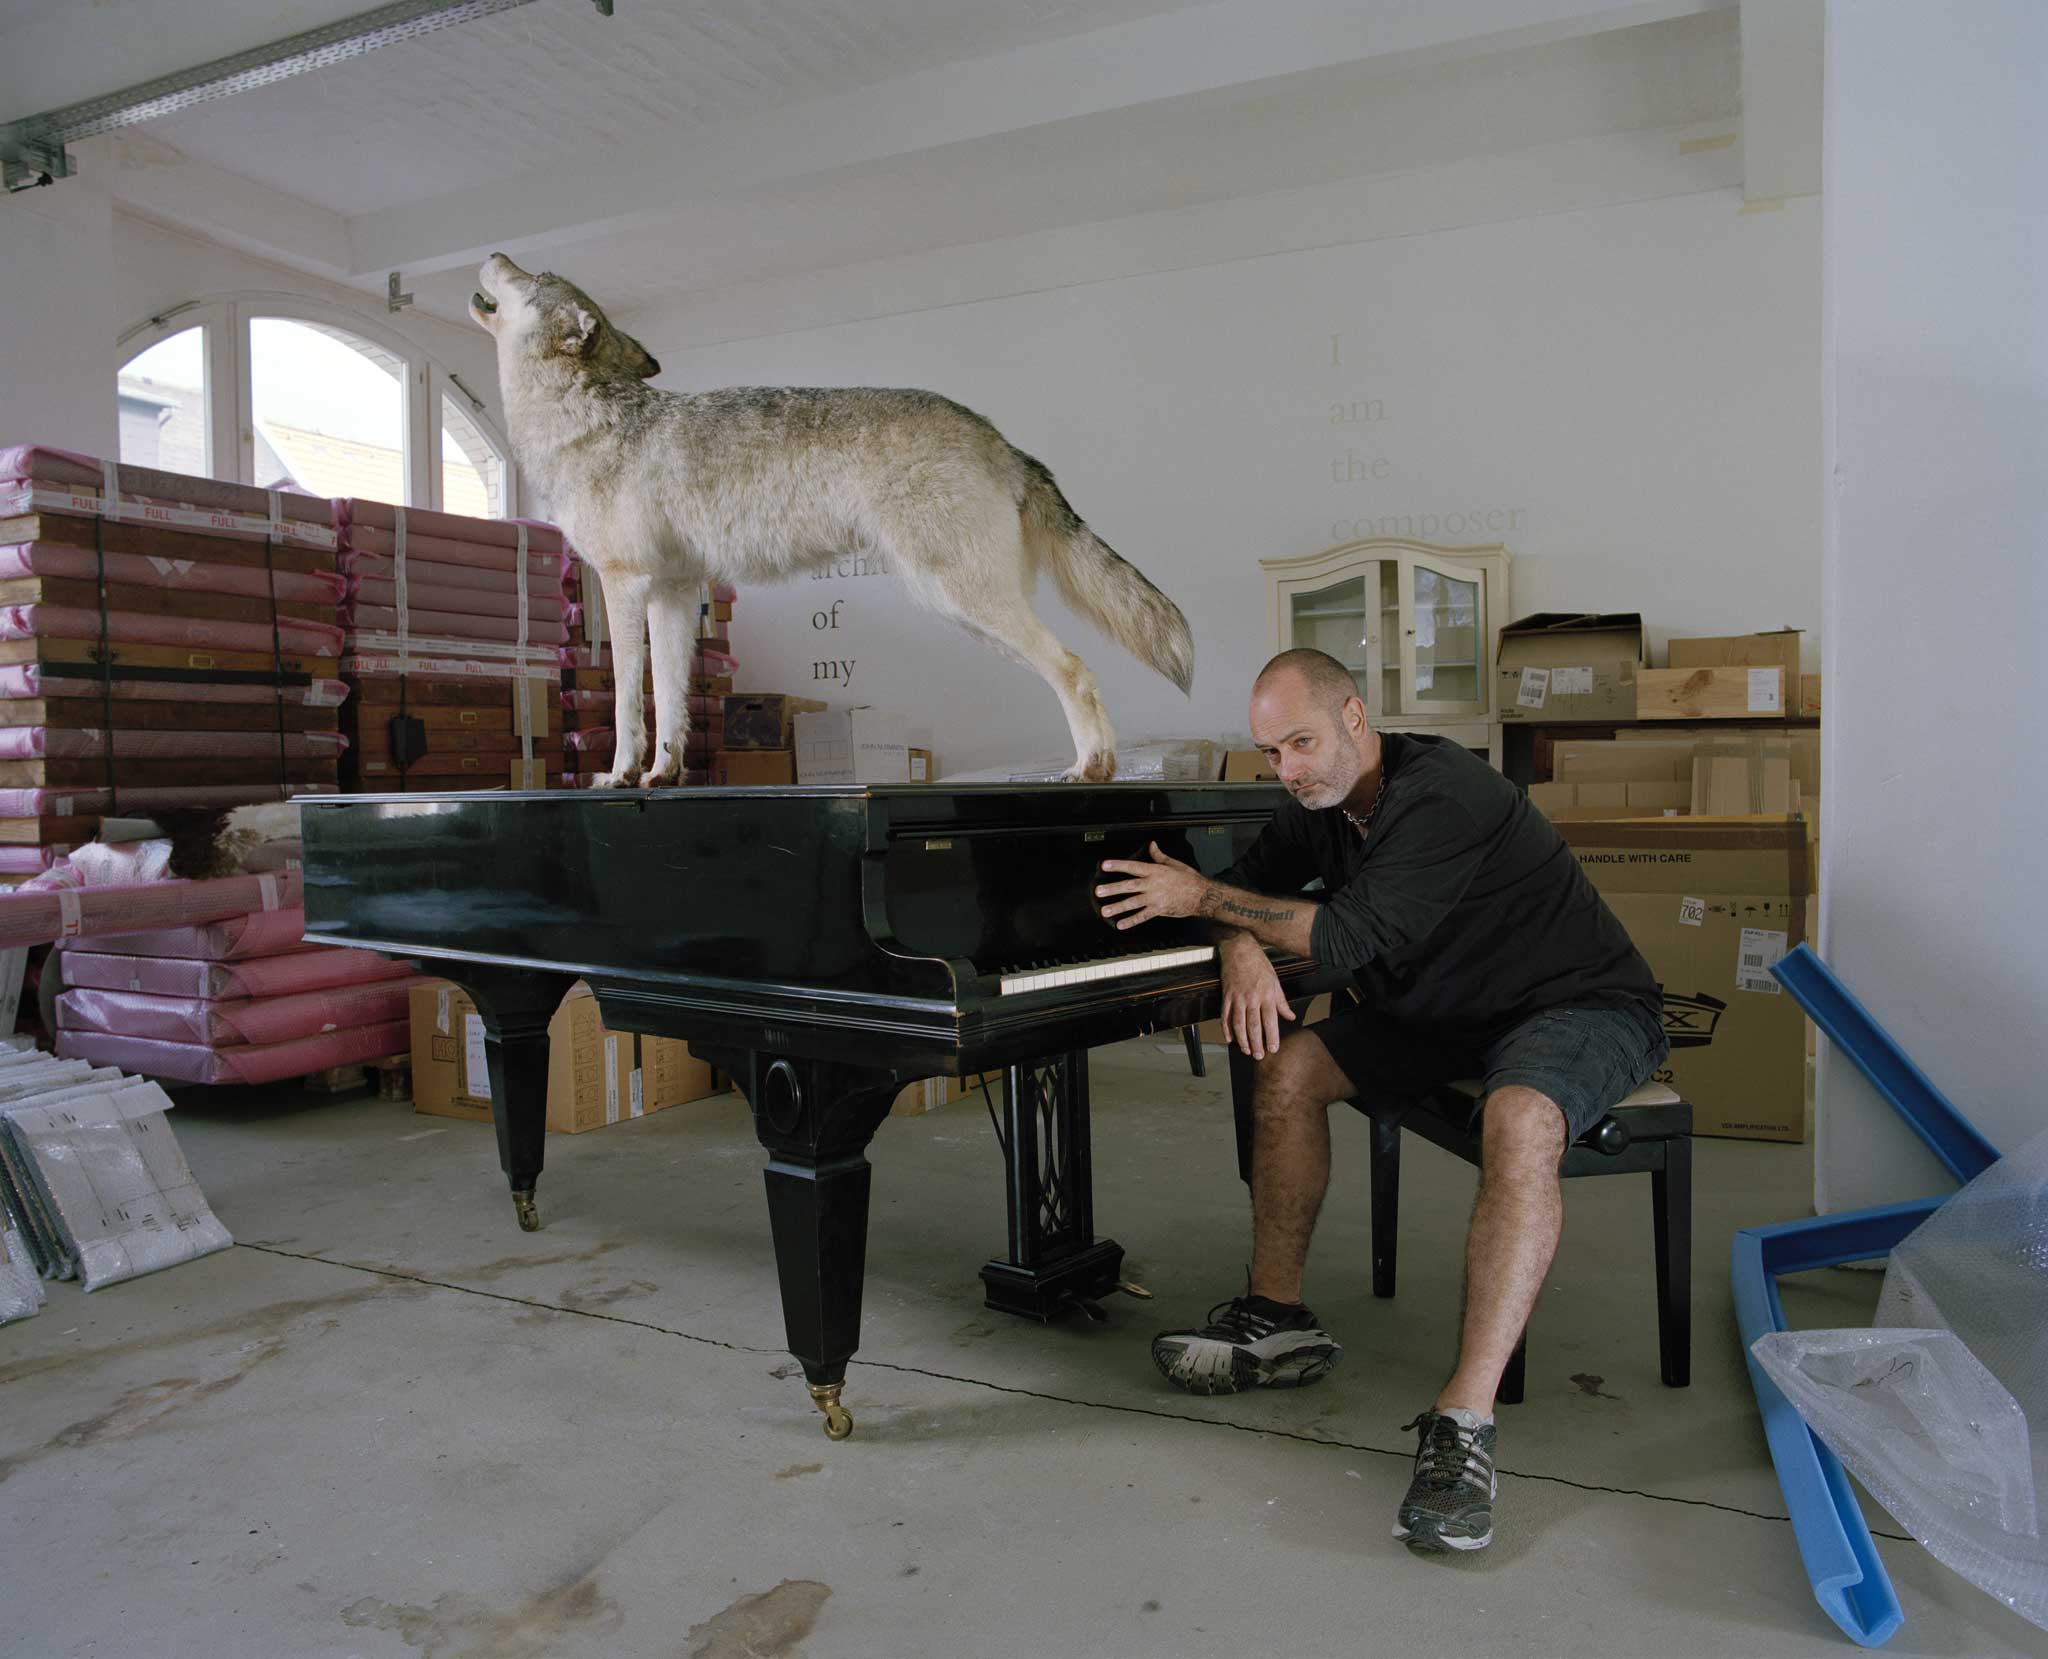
xmin=301 ymin=784 xmax=1327 ymax=1440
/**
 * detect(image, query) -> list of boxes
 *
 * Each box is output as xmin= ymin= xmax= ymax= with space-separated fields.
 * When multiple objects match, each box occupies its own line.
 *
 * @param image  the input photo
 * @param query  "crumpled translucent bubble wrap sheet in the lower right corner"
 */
xmin=1755 ymin=1133 xmax=2048 ymax=1630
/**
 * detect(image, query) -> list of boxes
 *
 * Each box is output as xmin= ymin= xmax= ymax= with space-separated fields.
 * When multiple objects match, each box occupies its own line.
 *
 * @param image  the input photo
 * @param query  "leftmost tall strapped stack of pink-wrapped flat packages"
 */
xmin=0 ymin=444 xmax=344 ymax=887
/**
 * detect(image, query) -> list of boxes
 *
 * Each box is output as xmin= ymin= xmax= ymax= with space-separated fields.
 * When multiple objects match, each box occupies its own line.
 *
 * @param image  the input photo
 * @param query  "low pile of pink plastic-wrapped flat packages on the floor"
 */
xmin=57 ymin=905 xmax=420 ymax=1083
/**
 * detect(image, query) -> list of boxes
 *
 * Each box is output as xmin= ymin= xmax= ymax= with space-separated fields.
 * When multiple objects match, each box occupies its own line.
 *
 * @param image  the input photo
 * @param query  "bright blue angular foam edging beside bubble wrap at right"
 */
xmin=1729 ymin=944 xmax=1999 ymax=1647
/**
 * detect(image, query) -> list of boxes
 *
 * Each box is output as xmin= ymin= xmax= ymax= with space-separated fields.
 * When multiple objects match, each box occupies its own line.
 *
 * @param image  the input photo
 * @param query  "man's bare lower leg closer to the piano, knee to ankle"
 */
xmin=1251 ymin=1030 xmax=1356 ymax=1303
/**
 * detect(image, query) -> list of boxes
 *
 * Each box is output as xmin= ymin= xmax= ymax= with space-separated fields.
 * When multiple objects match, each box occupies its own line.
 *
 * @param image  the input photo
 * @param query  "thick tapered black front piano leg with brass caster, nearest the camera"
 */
xmin=698 ymin=1049 xmax=903 ymax=1440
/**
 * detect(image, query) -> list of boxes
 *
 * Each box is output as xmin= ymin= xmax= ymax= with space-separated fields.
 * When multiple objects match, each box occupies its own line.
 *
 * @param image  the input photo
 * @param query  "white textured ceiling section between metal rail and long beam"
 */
xmin=136 ymin=0 xmax=1200 ymax=215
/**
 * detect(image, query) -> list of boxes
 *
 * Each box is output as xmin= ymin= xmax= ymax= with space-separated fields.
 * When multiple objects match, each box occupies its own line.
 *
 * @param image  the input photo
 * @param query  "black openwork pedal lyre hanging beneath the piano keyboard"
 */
xmin=981 ymin=1049 xmax=1151 ymax=1321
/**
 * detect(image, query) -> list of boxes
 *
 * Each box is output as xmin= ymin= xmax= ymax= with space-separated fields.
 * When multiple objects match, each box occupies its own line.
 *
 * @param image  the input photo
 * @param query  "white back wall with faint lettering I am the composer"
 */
xmin=631 ymin=190 xmax=1821 ymax=770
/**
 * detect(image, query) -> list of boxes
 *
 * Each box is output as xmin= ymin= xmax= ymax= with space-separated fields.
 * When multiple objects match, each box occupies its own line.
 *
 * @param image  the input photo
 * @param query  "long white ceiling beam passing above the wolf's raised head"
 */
xmin=348 ymin=0 xmax=1733 ymax=274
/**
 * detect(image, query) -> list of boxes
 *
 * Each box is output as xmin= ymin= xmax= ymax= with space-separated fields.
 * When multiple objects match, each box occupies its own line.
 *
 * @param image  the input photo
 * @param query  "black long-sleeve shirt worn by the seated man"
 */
xmin=1219 ymin=731 xmax=1661 ymax=1036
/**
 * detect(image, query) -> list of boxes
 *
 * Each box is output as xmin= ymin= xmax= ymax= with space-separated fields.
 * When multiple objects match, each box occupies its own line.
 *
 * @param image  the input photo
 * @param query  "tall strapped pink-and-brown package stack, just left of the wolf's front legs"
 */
xmin=334 ymin=500 xmax=578 ymax=791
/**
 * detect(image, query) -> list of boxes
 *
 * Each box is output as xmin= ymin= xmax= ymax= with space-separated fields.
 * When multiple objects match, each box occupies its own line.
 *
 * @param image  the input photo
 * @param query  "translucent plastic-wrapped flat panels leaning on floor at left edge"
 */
xmin=0 ymin=1055 xmax=233 ymax=1290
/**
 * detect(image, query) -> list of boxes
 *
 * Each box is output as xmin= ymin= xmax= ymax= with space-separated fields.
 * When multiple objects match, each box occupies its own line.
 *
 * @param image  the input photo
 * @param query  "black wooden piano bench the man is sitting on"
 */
xmin=1231 ymin=1049 xmax=1692 ymax=1405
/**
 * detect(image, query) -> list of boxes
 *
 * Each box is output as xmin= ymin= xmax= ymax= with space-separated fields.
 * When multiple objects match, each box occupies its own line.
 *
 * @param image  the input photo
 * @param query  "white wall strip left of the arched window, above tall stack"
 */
xmin=0 ymin=141 xmax=115 ymax=455
